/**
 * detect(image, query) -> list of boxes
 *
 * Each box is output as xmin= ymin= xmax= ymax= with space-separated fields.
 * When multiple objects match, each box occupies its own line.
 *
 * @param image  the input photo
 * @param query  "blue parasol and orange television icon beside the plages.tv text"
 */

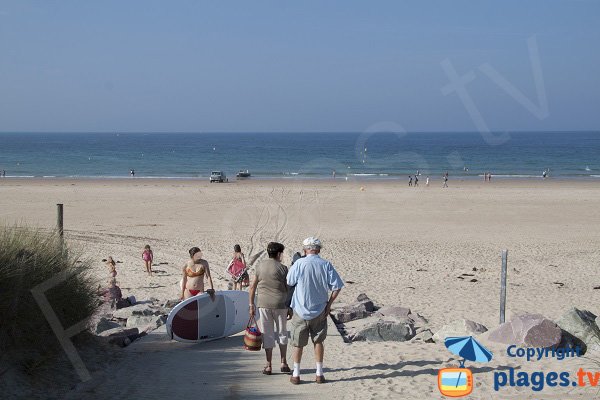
xmin=438 ymin=336 xmax=492 ymax=397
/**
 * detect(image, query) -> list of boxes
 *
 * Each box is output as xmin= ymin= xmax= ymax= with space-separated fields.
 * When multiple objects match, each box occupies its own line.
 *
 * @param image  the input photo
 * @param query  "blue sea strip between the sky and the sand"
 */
xmin=0 ymin=132 xmax=600 ymax=180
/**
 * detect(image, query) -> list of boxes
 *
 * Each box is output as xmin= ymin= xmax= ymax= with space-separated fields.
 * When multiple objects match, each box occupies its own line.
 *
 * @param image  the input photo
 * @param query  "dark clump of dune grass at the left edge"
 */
xmin=0 ymin=227 xmax=99 ymax=366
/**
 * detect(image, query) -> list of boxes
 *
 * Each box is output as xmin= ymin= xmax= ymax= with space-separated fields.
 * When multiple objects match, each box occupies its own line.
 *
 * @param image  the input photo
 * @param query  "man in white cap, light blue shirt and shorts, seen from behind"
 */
xmin=287 ymin=237 xmax=344 ymax=385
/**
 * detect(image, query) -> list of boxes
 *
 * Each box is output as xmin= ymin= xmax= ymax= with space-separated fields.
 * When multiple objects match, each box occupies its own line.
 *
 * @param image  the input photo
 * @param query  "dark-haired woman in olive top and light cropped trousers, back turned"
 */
xmin=249 ymin=242 xmax=292 ymax=375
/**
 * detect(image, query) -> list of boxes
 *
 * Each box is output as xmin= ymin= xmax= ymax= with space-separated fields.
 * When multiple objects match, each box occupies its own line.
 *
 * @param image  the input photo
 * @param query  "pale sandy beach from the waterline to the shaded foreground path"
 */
xmin=0 ymin=177 xmax=600 ymax=399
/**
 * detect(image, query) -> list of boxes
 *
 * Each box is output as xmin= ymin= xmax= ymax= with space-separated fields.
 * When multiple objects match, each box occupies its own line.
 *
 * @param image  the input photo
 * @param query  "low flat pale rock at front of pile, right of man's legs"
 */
xmin=348 ymin=319 xmax=415 ymax=342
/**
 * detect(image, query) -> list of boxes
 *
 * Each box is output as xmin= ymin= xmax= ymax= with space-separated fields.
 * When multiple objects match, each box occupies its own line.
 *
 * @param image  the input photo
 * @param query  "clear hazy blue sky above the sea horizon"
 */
xmin=0 ymin=0 xmax=600 ymax=132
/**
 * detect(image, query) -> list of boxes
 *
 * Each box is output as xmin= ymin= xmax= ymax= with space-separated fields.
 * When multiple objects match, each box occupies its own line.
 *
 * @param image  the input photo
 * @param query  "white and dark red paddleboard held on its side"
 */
xmin=166 ymin=290 xmax=258 ymax=343
